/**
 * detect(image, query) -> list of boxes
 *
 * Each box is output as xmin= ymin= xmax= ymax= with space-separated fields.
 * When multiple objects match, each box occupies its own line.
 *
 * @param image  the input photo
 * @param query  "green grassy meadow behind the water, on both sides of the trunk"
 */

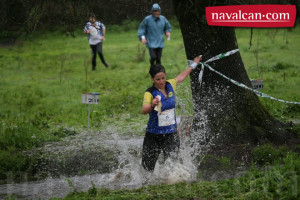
xmin=0 ymin=22 xmax=300 ymax=179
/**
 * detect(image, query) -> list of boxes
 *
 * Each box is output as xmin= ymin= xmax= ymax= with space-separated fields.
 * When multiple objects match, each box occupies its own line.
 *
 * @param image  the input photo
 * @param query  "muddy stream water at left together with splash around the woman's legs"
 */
xmin=0 ymin=84 xmax=216 ymax=199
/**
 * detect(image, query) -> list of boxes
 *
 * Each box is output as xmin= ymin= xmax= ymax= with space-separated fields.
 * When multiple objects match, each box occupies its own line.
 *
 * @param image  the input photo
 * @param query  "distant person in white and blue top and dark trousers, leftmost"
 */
xmin=83 ymin=14 xmax=109 ymax=70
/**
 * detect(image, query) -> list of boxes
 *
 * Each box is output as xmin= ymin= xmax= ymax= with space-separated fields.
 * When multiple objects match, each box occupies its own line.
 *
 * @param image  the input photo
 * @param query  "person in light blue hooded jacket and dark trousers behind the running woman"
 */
xmin=138 ymin=3 xmax=171 ymax=66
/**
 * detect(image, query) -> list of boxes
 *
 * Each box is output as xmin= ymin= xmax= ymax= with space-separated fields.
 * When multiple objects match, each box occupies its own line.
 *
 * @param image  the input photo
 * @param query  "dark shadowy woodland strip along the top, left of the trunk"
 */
xmin=0 ymin=0 xmax=174 ymax=40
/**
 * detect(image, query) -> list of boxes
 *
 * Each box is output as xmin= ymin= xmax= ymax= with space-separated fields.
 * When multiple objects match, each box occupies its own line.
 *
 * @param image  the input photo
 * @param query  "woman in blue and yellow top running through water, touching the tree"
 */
xmin=142 ymin=56 xmax=201 ymax=172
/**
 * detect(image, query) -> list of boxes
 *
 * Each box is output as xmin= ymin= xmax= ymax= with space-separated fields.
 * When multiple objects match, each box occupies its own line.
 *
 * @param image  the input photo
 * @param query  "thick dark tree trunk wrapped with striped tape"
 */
xmin=173 ymin=0 xmax=288 ymax=152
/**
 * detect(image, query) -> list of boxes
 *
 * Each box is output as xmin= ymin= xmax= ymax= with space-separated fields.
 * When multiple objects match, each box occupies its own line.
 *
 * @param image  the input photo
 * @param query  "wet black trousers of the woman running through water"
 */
xmin=142 ymin=132 xmax=180 ymax=172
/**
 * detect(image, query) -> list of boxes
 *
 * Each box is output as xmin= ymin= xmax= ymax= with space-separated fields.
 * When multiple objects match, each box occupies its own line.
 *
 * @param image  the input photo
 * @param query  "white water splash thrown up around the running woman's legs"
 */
xmin=105 ymin=83 xmax=212 ymax=187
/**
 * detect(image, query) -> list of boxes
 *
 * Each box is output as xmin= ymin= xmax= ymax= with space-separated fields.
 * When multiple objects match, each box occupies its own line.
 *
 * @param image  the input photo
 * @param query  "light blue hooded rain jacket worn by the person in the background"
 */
xmin=138 ymin=3 xmax=171 ymax=48
